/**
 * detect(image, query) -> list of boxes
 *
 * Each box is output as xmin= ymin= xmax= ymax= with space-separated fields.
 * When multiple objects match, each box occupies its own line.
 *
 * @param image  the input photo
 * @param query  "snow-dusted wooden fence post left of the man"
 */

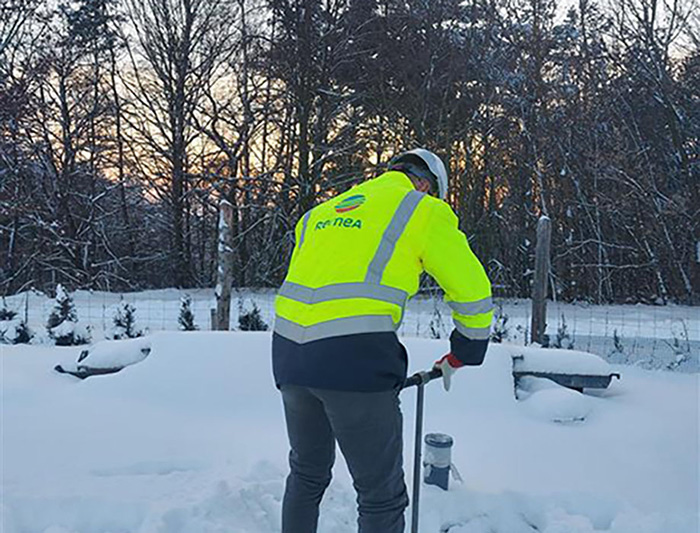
xmin=213 ymin=200 xmax=233 ymax=331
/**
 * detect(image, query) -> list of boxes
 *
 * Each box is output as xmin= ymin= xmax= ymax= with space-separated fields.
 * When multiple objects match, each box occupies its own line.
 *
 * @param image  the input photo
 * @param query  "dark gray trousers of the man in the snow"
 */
xmin=281 ymin=385 xmax=408 ymax=533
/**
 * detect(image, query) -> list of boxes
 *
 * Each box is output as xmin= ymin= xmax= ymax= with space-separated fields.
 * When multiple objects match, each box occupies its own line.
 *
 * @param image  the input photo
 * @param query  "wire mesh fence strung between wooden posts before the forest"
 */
xmin=6 ymin=289 xmax=700 ymax=372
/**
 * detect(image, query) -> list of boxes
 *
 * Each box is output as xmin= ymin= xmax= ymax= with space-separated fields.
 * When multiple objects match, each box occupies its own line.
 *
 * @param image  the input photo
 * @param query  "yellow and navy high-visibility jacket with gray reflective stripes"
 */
xmin=273 ymin=171 xmax=493 ymax=390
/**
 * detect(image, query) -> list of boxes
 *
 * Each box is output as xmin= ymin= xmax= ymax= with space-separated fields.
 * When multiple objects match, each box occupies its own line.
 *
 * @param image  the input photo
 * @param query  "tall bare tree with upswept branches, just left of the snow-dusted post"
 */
xmin=125 ymin=0 xmax=237 ymax=286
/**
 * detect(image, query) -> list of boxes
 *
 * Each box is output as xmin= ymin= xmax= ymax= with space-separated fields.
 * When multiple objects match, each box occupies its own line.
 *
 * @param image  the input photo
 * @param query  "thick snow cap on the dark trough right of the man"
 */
xmin=513 ymin=347 xmax=613 ymax=376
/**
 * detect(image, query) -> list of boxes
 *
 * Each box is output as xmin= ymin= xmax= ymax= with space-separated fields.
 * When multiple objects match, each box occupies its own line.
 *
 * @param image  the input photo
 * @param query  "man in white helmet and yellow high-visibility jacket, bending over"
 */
xmin=272 ymin=148 xmax=492 ymax=533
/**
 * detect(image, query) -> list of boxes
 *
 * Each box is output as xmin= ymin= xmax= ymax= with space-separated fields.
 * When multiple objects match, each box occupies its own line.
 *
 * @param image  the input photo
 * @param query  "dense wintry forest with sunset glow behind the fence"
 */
xmin=0 ymin=0 xmax=700 ymax=304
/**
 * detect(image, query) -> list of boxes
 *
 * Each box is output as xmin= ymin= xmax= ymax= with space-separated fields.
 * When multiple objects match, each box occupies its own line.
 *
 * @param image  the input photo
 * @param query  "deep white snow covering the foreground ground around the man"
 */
xmin=0 ymin=330 xmax=699 ymax=533
